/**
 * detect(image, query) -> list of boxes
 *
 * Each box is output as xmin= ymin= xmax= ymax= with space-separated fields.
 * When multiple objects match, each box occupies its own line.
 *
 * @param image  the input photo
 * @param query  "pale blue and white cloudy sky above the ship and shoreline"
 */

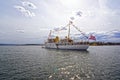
xmin=0 ymin=0 xmax=120 ymax=44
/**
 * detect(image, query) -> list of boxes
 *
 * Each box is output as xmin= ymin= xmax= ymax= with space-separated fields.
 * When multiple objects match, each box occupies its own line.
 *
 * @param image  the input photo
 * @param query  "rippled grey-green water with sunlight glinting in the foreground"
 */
xmin=0 ymin=46 xmax=120 ymax=80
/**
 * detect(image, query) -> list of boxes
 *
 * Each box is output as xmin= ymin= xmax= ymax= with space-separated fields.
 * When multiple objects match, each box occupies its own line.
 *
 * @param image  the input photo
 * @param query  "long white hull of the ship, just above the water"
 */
xmin=45 ymin=43 xmax=89 ymax=50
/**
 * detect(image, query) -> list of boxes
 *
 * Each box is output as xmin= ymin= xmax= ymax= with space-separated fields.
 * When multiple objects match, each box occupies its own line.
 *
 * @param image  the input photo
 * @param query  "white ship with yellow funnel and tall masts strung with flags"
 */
xmin=45 ymin=21 xmax=89 ymax=50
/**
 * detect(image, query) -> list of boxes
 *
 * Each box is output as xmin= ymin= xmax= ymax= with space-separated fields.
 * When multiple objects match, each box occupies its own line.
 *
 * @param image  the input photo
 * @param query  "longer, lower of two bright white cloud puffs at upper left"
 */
xmin=14 ymin=5 xmax=35 ymax=17
